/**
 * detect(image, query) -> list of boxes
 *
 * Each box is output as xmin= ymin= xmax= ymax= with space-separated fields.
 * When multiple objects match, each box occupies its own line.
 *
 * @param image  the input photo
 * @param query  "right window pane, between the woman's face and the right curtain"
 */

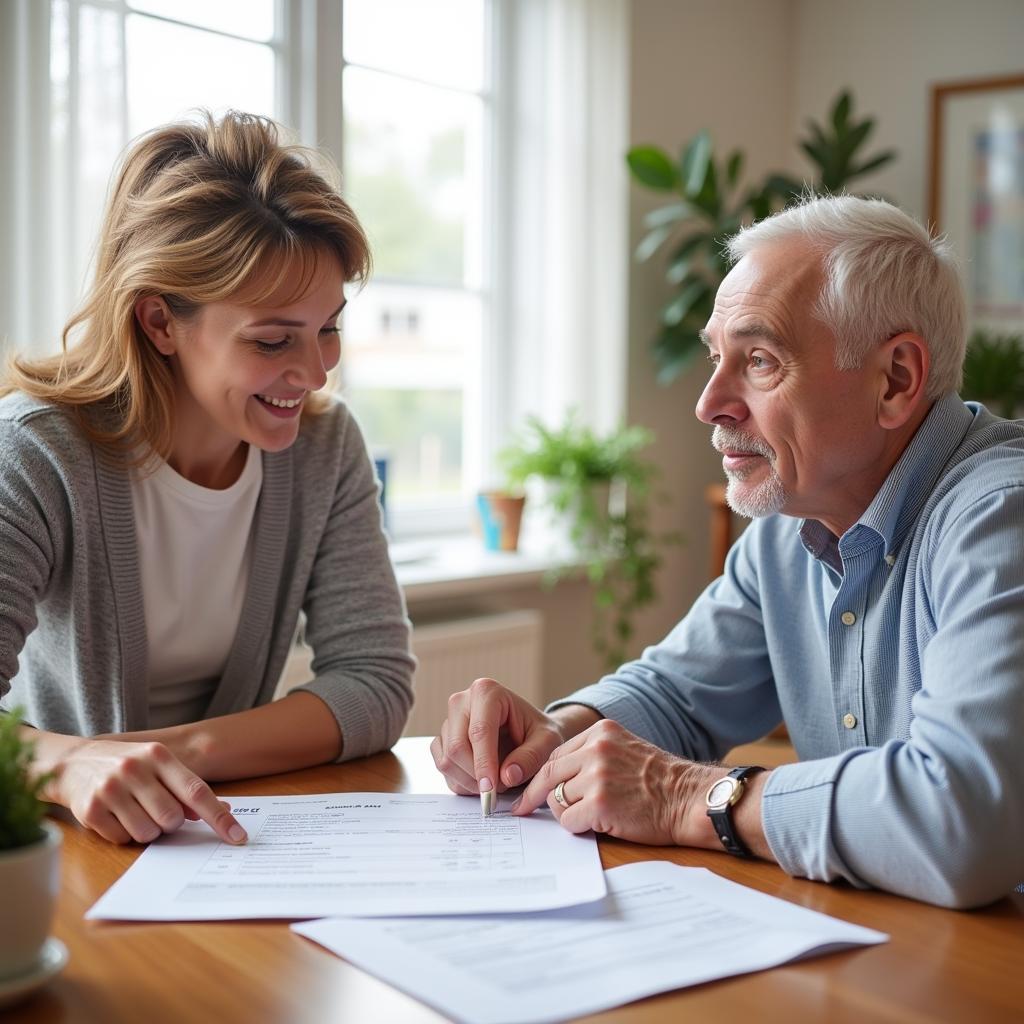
xmin=342 ymin=0 xmax=493 ymax=525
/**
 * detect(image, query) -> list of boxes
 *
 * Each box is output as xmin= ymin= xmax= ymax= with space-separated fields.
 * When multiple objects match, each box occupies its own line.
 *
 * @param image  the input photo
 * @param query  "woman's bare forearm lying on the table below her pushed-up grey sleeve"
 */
xmin=108 ymin=691 xmax=343 ymax=781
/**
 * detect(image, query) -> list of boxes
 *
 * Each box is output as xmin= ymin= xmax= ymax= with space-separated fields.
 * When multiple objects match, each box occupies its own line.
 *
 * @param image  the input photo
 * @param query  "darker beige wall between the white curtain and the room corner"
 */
xmin=628 ymin=0 xmax=795 ymax=642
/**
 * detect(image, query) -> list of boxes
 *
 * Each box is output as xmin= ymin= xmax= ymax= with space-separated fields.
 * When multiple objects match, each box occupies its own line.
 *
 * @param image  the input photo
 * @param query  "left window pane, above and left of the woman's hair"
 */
xmin=49 ymin=0 xmax=281 ymax=348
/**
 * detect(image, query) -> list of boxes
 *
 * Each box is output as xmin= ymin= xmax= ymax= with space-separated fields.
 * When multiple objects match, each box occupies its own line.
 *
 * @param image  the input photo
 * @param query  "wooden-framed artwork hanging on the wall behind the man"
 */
xmin=929 ymin=74 xmax=1024 ymax=333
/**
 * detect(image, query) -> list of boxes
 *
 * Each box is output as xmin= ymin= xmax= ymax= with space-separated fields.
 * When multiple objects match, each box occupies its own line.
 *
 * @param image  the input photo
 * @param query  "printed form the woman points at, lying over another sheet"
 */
xmin=86 ymin=793 xmax=606 ymax=921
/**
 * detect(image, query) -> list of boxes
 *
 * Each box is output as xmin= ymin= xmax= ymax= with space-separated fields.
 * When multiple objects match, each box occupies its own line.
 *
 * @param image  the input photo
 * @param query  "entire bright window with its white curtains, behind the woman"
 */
xmin=8 ymin=0 xmax=628 ymax=534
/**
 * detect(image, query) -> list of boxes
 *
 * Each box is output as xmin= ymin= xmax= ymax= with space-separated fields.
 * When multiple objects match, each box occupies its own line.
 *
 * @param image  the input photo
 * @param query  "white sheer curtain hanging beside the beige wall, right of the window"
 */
xmin=495 ymin=0 xmax=630 ymax=444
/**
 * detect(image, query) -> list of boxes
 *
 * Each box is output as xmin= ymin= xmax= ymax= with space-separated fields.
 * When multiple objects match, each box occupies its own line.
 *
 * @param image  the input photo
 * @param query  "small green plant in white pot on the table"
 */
xmin=0 ymin=710 xmax=68 ymax=1001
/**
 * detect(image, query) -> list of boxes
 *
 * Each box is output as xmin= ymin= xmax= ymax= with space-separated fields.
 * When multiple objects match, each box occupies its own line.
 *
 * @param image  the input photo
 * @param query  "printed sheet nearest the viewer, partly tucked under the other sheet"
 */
xmin=292 ymin=861 xmax=888 ymax=1024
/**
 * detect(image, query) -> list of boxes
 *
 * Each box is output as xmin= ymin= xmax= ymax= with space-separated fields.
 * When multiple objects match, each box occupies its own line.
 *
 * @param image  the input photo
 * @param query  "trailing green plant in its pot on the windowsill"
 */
xmin=499 ymin=414 xmax=678 ymax=668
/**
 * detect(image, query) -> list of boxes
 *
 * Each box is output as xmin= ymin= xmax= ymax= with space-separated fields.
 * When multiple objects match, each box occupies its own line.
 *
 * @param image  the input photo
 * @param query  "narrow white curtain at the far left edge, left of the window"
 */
xmin=0 ymin=0 xmax=59 ymax=353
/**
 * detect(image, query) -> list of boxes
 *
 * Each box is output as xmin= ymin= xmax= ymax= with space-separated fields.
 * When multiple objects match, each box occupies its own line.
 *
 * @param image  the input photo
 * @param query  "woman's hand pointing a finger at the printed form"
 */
xmin=44 ymin=739 xmax=247 ymax=844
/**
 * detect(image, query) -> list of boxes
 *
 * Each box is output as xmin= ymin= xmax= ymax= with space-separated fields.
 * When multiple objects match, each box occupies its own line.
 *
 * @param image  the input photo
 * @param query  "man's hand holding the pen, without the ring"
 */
xmin=430 ymin=679 xmax=573 ymax=796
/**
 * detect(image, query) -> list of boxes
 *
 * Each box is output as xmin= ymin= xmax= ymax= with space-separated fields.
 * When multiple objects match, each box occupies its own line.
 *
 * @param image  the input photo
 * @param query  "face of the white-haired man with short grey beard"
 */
xmin=696 ymin=242 xmax=885 ymax=536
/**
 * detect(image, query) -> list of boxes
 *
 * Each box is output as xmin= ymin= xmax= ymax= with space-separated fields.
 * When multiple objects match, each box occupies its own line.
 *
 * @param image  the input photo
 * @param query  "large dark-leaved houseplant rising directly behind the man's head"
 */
xmin=626 ymin=92 xmax=895 ymax=384
